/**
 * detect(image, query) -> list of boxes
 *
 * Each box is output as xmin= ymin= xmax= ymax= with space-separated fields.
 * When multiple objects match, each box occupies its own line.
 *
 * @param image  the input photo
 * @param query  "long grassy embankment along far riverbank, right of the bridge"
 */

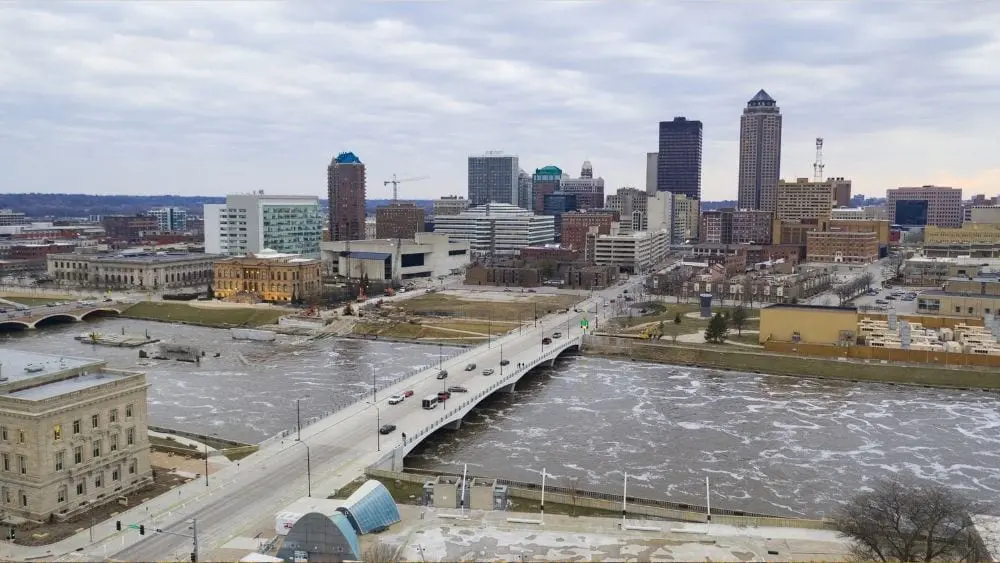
xmin=583 ymin=336 xmax=1000 ymax=391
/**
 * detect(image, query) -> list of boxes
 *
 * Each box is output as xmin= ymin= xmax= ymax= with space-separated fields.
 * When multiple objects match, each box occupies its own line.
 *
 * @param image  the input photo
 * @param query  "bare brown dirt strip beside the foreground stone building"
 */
xmin=15 ymin=468 xmax=190 ymax=545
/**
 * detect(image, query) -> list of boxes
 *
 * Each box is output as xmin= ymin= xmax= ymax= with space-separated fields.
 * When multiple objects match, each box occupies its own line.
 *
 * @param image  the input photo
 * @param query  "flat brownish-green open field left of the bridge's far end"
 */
xmin=394 ymin=293 xmax=581 ymax=322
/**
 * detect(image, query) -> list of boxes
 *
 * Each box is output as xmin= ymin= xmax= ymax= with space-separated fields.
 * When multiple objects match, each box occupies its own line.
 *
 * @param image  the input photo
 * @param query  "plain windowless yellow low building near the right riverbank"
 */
xmin=760 ymin=304 xmax=858 ymax=345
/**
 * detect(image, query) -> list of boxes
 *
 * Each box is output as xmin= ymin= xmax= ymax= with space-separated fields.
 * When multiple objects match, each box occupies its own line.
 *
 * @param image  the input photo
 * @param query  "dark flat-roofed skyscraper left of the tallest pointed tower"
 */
xmin=647 ymin=117 xmax=701 ymax=199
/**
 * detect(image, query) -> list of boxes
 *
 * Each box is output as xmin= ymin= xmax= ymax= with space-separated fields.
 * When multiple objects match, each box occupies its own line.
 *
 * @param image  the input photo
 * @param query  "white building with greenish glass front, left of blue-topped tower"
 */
xmin=205 ymin=191 xmax=323 ymax=258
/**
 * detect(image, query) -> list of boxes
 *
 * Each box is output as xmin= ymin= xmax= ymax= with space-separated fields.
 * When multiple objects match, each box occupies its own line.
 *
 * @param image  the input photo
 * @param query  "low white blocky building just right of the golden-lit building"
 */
xmin=322 ymin=233 xmax=471 ymax=282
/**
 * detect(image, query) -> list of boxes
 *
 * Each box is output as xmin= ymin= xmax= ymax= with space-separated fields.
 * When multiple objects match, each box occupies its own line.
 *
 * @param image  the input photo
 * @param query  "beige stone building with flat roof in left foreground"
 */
xmin=0 ymin=348 xmax=152 ymax=521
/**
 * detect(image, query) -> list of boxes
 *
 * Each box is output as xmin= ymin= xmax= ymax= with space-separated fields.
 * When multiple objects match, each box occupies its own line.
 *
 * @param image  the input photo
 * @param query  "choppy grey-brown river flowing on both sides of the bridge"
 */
xmin=0 ymin=319 xmax=1000 ymax=517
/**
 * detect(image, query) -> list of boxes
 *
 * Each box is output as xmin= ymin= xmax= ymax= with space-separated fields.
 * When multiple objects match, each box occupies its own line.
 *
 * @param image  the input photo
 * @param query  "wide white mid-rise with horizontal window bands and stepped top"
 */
xmin=434 ymin=203 xmax=555 ymax=255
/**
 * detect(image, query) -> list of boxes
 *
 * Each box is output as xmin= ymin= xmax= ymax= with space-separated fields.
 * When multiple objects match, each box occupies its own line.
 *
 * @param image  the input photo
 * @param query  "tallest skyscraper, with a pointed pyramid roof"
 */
xmin=738 ymin=90 xmax=781 ymax=212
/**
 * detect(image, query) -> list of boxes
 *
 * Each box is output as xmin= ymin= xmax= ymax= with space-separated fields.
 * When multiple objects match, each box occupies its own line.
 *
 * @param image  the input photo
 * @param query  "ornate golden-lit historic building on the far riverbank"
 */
xmin=212 ymin=249 xmax=322 ymax=302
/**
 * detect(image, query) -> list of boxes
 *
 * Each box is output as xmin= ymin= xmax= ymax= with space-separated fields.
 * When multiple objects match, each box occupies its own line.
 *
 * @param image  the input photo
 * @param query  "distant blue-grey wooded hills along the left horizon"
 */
xmin=0 ymin=194 xmax=433 ymax=219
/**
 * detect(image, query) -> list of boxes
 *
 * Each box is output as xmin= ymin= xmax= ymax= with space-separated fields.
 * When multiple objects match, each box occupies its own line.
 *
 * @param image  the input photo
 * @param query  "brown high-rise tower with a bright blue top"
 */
xmin=326 ymin=152 xmax=366 ymax=240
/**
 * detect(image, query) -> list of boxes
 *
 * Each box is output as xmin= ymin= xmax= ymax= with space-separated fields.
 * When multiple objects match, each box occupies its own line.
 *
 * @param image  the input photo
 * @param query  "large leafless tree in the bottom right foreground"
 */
xmin=834 ymin=478 xmax=989 ymax=561
